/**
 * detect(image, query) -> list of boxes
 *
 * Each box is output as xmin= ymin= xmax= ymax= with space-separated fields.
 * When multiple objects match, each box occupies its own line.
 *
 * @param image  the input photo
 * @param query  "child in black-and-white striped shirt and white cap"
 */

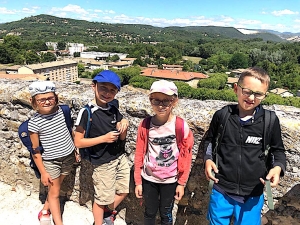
xmin=28 ymin=81 xmax=76 ymax=225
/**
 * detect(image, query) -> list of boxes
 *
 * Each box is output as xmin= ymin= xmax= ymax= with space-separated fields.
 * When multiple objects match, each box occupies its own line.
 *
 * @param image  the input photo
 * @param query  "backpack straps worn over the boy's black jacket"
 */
xmin=208 ymin=105 xmax=276 ymax=209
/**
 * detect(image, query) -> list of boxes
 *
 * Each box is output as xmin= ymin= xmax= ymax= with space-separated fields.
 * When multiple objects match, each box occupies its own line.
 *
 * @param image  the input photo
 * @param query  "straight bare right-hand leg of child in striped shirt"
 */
xmin=48 ymin=175 xmax=65 ymax=225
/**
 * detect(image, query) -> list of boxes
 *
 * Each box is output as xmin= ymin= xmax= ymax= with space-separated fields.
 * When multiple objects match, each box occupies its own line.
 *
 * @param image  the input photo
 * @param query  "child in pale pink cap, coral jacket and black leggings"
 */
xmin=134 ymin=80 xmax=194 ymax=225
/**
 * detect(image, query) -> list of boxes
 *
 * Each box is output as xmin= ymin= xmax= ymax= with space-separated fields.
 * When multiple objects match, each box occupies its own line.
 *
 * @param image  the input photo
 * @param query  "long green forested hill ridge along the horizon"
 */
xmin=0 ymin=14 xmax=284 ymax=45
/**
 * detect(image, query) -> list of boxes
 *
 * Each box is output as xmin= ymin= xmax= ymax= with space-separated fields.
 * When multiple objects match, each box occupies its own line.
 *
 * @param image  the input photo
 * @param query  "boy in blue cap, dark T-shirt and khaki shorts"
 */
xmin=74 ymin=70 xmax=130 ymax=225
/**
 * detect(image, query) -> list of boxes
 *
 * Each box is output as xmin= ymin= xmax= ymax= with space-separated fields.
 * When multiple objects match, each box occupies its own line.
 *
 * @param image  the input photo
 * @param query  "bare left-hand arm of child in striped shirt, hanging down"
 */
xmin=29 ymin=132 xmax=52 ymax=186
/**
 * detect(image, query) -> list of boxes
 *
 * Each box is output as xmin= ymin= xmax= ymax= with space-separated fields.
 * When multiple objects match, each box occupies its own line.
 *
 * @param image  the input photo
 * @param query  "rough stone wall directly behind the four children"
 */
xmin=0 ymin=80 xmax=300 ymax=225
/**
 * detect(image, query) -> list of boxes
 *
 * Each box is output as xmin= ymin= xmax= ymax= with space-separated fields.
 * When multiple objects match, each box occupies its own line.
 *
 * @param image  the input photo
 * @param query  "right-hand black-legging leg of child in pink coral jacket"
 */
xmin=159 ymin=182 xmax=177 ymax=225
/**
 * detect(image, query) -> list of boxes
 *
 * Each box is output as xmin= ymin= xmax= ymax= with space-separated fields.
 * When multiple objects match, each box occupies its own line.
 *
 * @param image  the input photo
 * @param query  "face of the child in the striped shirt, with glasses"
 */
xmin=34 ymin=92 xmax=57 ymax=114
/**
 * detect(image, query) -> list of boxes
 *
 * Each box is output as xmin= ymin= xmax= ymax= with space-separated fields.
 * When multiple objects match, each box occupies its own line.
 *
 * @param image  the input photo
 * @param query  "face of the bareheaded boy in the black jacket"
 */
xmin=234 ymin=76 xmax=268 ymax=112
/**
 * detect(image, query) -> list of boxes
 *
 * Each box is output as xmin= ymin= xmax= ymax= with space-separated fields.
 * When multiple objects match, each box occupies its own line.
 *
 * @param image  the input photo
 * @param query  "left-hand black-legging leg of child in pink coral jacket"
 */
xmin=143 ymin=179 xmax=161 ymax=225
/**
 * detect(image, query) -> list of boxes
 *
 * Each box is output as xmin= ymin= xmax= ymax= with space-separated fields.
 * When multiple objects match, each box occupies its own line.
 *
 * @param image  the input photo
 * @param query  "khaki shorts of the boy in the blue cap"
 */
xmin=92 ymin=154 xmax=130 ymax=205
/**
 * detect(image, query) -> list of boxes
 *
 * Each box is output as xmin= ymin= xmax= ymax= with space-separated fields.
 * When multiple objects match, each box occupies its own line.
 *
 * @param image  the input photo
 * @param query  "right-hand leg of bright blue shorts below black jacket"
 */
xmin=234 ymin=194 xmax=264 ymax=225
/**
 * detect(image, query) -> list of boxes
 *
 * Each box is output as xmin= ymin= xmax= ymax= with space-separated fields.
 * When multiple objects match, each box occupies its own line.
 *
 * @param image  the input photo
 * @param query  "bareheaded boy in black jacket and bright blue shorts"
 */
xmin=204 ymin=67 xmax=286 ymax=225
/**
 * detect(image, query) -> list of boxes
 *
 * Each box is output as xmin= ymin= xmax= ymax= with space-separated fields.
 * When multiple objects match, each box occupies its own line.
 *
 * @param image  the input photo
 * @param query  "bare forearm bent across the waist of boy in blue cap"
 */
xmin=74 ymin=126 xmax=119 ymax=148
